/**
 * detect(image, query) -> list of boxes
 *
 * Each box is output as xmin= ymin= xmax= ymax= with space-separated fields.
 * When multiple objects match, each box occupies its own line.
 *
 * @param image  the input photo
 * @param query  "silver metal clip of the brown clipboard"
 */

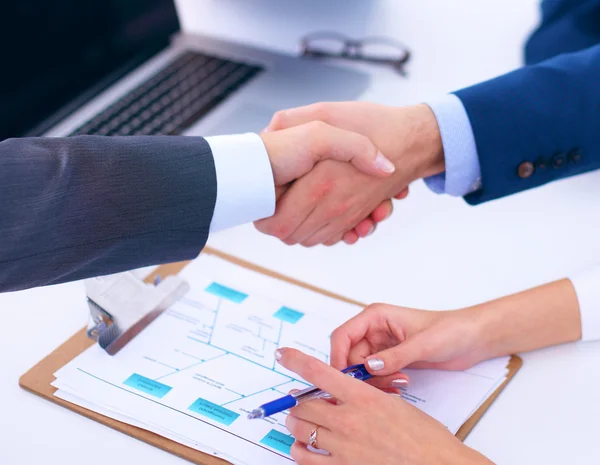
xmin=85 ymin=271 xmax=190 ymax=355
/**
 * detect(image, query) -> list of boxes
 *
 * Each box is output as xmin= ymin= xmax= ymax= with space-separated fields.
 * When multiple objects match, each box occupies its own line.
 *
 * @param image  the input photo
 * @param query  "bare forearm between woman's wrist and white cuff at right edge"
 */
xmin=474 ymin=279 xmax=581 ymax=358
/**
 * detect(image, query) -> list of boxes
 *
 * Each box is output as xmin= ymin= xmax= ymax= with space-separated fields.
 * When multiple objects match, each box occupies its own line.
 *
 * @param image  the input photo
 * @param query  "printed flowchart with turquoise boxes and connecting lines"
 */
xmin=73 ymin=272 xmax=335 ymax=458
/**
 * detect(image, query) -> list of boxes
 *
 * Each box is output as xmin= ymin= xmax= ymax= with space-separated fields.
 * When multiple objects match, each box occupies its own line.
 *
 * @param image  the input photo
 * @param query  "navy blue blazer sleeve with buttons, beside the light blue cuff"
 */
xmin=456 ymin=45 xmax=600 ymax=204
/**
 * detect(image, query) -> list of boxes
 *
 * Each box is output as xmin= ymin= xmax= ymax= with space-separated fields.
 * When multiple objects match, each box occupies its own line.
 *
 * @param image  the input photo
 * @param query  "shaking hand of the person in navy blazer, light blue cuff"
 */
xmin=255 ymin=102 xmax=444 ymax=246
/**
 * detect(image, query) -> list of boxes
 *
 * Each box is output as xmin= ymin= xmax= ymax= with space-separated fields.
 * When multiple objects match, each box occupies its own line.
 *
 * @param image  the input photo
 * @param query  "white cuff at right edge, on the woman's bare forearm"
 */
xmin=570 ymin=267 xmax=600 ymax=341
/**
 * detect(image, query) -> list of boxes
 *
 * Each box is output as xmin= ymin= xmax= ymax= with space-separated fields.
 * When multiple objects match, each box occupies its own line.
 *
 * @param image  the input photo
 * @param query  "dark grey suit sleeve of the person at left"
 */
xmin=0 ymin=136 xmax=217 ymax=292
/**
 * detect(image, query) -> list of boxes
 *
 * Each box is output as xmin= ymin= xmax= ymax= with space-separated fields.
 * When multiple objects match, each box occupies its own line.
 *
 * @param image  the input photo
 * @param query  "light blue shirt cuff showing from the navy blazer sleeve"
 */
xmin=425 ymin=94 xmax=481 ymax=197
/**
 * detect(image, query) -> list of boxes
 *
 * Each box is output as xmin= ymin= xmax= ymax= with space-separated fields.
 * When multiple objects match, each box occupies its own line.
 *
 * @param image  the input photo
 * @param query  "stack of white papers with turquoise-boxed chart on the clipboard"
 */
xmin=53 ymin=256 xmax=508 ymax=465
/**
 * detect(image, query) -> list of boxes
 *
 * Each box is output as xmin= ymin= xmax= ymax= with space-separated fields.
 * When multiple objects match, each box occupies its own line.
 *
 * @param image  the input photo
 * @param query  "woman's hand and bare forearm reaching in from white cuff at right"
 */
xmin=331 ymin=279 xmax=581 ymax=381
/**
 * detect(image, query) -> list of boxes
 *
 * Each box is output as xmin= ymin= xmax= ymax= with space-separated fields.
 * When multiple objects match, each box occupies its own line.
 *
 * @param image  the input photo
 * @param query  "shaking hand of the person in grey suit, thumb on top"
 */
xmin=261 ymin=121 xmax=395 ymax=188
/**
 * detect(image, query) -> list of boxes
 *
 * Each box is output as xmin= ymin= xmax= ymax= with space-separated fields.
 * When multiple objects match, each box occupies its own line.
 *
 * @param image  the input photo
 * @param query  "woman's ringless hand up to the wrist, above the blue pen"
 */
xmin=331 ymin=304 xmax=491 ymax=376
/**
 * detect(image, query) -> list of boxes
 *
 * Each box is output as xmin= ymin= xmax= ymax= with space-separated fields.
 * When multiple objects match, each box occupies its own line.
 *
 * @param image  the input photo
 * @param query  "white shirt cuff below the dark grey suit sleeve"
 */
xmin=206 ymin=133 xmax=275 ymax=232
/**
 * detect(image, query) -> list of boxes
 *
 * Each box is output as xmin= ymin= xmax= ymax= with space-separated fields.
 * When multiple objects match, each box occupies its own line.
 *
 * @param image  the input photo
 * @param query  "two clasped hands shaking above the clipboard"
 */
xmin=255 ymin=102 xmax=445 ymax=247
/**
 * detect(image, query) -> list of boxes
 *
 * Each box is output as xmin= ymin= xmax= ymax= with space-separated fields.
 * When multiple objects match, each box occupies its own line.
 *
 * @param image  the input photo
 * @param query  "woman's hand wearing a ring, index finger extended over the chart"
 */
xmin=276 ymin=349 xmax=491 ymax=465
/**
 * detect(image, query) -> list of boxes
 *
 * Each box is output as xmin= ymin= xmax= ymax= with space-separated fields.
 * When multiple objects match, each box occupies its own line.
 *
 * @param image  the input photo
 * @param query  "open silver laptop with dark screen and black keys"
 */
xmin=0 ymin=0 xmax=369 ymax=140
